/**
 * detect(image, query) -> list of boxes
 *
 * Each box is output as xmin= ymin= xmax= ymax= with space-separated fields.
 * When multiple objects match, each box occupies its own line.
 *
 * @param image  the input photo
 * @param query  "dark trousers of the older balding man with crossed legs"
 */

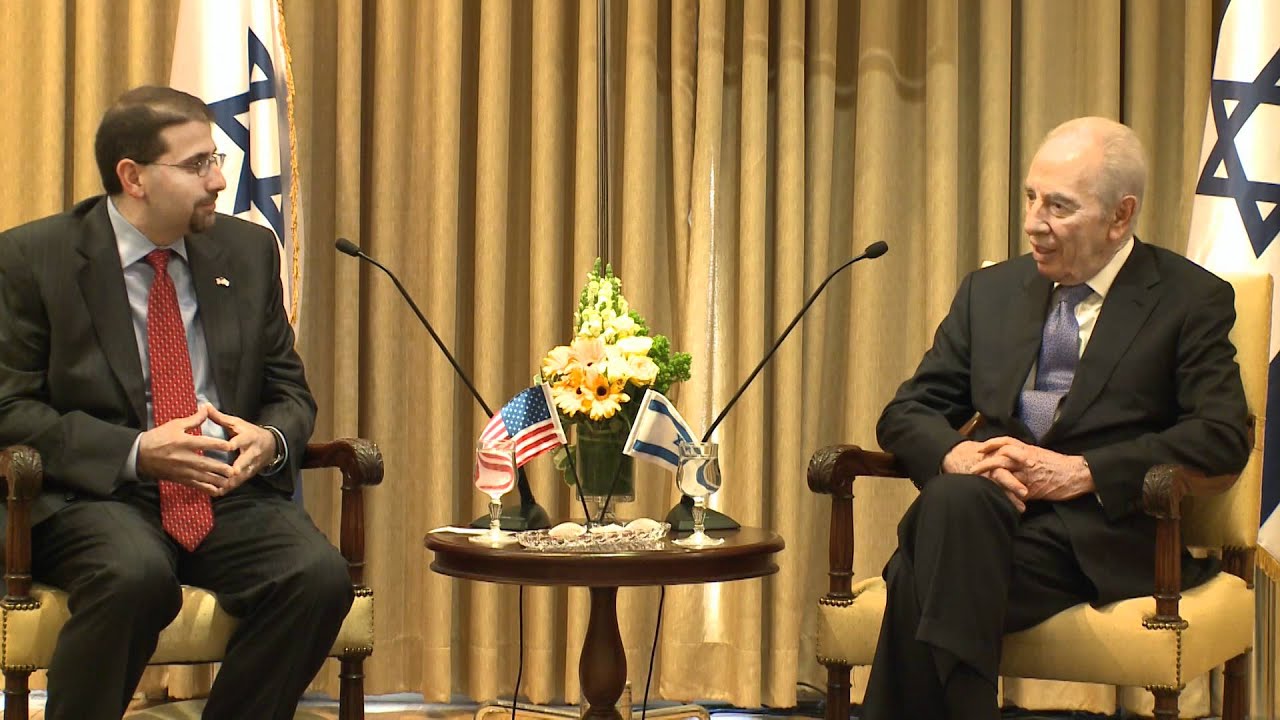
xmin=861 ymin=475 xmax=1096 ymax=720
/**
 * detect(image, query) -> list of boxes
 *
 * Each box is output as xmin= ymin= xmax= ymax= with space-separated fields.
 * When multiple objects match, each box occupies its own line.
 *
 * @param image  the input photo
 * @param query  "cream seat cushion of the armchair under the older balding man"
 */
xmin=818 ymin=573 xmax=1253 ymax=688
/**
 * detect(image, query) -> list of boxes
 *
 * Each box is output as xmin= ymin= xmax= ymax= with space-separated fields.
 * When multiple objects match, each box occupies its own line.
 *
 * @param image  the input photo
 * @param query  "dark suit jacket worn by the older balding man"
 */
xmin=877 ymin=241 xmax=1248 ymax=602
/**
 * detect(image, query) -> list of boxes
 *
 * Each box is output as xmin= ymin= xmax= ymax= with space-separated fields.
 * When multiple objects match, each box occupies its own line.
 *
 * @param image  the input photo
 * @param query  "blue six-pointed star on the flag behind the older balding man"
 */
xmin=1196 ymin=43 xmax=1280 ymax=258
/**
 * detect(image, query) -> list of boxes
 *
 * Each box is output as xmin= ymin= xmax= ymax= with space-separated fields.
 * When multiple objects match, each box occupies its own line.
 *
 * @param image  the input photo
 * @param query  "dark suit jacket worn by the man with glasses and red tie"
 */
xmin=0 ymin=196 xmax=316 ymax=521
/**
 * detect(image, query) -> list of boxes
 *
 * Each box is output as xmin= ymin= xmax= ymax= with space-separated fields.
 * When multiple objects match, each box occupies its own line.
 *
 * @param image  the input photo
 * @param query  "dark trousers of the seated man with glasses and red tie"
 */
xmin=32 ymin=484 xmax=353 ymax=720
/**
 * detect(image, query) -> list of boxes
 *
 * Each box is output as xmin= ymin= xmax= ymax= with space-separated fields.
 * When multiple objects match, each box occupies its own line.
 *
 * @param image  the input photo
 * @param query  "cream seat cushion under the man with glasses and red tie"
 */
xmin=0 ymin=583 xmax=374 ymax=670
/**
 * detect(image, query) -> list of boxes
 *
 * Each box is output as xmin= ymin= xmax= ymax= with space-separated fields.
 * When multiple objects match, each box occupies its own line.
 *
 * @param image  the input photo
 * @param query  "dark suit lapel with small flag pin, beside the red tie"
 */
xmin=187 ymin=233 xmax=241 ymax=413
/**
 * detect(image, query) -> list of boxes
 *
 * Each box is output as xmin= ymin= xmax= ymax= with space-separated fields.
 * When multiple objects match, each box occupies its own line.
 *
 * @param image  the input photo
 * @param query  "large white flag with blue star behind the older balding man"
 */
xmin=1187 ymin=0 xmax=1280 ymax=569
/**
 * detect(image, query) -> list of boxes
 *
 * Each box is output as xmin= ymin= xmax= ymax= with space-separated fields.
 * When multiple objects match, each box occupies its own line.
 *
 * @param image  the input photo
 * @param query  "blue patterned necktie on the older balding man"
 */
xmin=1020 ymin=284 xmax=1093 ymax=439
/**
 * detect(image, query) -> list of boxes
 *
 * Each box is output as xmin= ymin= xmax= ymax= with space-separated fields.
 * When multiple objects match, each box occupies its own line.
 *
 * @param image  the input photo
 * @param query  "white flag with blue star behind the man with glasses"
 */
xmin=169 ymin=0 xmax=302 ymax=325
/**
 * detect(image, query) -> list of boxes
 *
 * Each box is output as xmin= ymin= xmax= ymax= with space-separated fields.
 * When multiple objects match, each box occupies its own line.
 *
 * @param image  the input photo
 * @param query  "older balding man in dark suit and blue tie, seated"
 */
xmin=863 ymin=118 xmax=1248 ymax=720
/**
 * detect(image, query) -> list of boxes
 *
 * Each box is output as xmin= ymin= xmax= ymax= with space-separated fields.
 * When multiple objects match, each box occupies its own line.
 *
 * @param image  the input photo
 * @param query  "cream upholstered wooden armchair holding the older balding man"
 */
xmin=809 ymin=270 xmax=1271 ymax=720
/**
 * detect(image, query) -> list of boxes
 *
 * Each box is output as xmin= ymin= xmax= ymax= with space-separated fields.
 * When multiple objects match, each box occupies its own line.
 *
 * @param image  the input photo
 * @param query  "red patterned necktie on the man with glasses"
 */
xmin=145 ymin=250 xmax=214 ymax=551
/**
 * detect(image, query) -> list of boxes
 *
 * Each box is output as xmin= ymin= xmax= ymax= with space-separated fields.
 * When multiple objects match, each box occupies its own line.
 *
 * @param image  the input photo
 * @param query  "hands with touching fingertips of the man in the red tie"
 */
xmin=137 ymin=404 xmax=275 ymax=497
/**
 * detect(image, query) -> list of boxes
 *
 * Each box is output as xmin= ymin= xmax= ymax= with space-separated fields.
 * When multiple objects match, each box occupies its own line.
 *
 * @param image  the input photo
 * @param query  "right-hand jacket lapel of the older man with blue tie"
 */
xmin=1046 ymin=240 xmax=1160 ymax=439
